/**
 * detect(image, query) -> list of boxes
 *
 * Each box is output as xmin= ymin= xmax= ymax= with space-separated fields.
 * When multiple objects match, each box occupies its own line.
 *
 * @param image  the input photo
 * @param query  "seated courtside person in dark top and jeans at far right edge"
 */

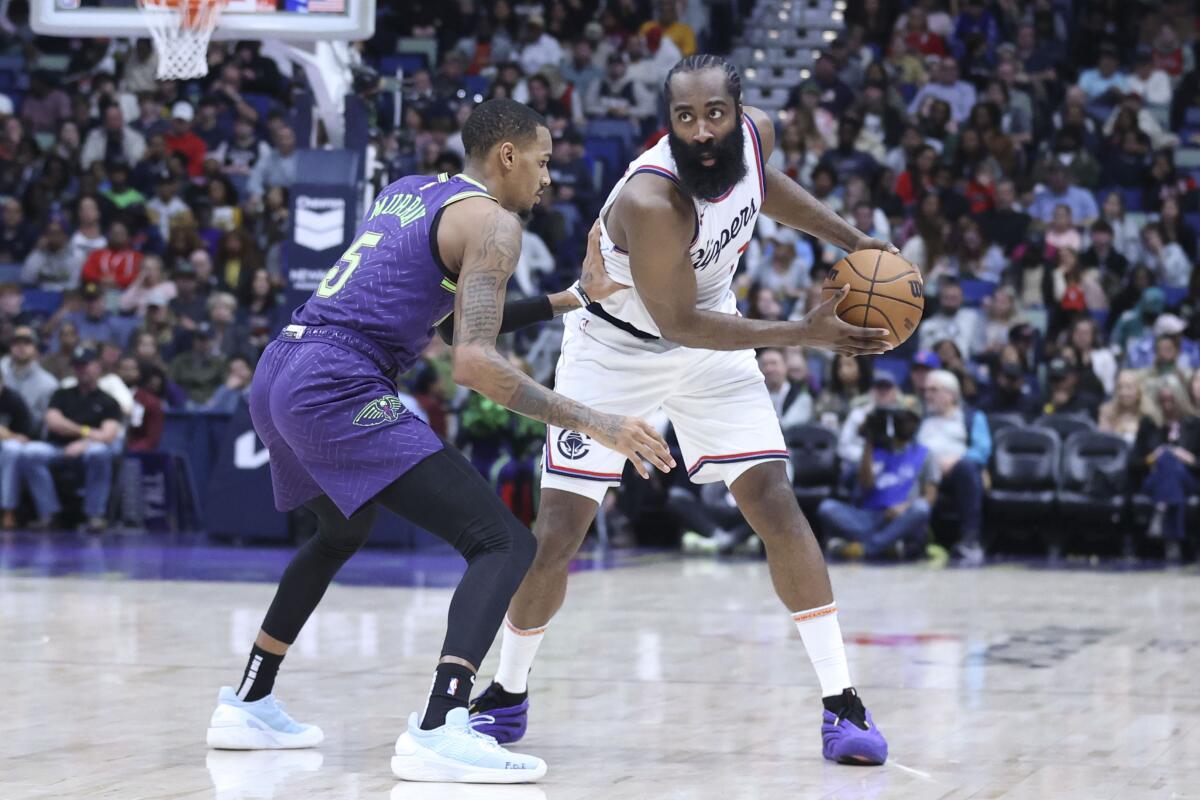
xmin=1129 ymin=375 xmax=1200 ymax=563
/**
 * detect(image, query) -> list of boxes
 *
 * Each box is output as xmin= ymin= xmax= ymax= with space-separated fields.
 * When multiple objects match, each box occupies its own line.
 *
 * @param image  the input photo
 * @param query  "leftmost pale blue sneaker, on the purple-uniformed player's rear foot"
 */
xmin=208 ymin=686 xmax=325 ymax=750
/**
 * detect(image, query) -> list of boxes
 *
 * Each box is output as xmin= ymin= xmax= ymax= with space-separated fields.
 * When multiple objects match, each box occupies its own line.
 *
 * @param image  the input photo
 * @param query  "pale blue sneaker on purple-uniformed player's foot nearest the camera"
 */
xmin=391 ymin=709 xmax=546 ymax=783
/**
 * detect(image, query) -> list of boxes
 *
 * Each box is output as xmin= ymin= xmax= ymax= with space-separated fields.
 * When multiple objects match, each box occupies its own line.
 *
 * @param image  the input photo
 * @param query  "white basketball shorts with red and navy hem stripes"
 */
xmin=541 ymin=312 xmax=787 ymax=503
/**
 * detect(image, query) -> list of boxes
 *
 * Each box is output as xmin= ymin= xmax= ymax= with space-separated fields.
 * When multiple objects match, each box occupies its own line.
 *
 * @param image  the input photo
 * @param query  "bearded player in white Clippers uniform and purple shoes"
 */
xmin=472 ymin=55 xmax=895 ymax=764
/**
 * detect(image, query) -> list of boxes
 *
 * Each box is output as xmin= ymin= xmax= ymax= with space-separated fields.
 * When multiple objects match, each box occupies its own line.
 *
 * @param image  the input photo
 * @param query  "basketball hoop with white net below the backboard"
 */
xmin=138 ymin=0 xmax=229 ymax=80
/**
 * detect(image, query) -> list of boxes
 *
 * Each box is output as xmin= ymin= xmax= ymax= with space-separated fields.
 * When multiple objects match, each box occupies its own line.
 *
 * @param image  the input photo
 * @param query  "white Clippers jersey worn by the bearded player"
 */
xmin=587 ymin=114 xmax=767 ymax=350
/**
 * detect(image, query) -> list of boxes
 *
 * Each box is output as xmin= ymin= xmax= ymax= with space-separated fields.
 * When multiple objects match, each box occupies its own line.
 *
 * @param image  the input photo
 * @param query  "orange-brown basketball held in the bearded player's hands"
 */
xmin=821 ymin=249 xmax=925 ymax=347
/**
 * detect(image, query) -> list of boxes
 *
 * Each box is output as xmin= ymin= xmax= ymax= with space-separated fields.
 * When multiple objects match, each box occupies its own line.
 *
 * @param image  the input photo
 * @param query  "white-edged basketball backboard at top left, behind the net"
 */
xmin=29 ymin=0 xmax=376 ymax=42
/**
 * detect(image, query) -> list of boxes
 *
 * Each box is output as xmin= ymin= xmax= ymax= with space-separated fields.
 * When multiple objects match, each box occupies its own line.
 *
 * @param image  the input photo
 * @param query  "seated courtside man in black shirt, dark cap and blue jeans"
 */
xmin=20 ymin=347 xmax=121 ymax=534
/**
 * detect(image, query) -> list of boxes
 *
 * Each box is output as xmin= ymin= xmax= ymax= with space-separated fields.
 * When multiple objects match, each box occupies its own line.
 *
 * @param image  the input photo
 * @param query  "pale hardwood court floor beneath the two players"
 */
xmin=0 ymin=549 xmax=1200 ymax=800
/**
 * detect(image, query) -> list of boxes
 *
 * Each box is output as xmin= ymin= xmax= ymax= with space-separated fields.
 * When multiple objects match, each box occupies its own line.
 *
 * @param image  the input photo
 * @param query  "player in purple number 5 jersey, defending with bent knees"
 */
xmin=208 ymin=100 xmax=673 ymax=783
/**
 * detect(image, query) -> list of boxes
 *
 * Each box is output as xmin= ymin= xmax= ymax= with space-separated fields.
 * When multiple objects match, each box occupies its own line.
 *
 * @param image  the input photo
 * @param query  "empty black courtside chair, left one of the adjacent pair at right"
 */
xmin=988 ymin=427 xmax=1062 ymax=521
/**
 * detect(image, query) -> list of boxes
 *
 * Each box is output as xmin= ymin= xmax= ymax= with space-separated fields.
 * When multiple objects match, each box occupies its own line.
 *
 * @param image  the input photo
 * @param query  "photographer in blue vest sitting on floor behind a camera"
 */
xmin=817 ymin=408 xmax=934 ymax=561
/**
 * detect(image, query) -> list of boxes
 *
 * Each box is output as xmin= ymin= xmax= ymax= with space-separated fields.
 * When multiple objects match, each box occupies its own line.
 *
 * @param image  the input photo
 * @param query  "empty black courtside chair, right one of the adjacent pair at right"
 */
xmin=1058 ymin=431 xmax=1129 ymax=546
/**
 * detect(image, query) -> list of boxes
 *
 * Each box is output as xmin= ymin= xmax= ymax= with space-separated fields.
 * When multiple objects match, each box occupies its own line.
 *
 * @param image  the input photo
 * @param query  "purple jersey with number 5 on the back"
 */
xmin=292 ymin=173 xmax=491 ymax=373
